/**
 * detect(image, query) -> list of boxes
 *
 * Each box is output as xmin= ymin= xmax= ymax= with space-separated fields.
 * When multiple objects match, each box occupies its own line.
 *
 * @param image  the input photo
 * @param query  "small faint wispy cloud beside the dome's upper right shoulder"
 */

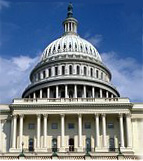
xmin=84 ymin=33 xmax=103 ymax=47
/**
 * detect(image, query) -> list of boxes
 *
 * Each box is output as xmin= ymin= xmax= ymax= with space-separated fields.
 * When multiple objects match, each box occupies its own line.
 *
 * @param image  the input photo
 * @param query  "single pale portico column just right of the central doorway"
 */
xmin=78 ymin=114 xmax=82 ymax=150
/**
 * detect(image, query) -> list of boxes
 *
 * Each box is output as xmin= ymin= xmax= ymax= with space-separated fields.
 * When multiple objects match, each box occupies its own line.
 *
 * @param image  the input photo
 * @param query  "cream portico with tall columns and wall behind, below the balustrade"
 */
xmin=10 ymin=97 xmax=132 ymax=152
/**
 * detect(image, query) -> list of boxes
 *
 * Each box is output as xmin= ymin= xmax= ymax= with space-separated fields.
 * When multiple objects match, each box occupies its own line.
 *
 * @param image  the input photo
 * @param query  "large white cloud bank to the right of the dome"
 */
xmin=101 ymin=52 xmax=143 ymax=102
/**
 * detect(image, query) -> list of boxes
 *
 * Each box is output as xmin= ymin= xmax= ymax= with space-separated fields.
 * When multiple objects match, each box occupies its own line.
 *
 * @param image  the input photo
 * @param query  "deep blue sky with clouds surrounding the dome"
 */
xmin=0 ymin=0 xmax=143 ymax=103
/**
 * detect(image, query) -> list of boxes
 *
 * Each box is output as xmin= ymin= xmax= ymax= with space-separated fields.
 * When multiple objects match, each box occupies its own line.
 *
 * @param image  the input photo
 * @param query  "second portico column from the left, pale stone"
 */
xmin=19 ymin=115 xmax=24 ymax=149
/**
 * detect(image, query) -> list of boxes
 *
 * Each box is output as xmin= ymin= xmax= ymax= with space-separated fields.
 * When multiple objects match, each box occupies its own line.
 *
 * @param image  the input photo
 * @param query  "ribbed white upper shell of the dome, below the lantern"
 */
xmin=41 ymin=34 xmax=102 ymax=61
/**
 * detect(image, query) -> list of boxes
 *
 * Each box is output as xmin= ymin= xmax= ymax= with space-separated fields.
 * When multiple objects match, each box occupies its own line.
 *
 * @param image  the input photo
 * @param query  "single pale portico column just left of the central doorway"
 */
xmin=60 ymin=114 xmax=65 ymax=151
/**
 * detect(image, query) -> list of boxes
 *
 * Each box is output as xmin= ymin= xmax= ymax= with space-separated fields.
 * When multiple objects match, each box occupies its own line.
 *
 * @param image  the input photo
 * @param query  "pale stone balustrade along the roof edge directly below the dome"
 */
xmin=13 ymin=97 xmax=130 ymax=104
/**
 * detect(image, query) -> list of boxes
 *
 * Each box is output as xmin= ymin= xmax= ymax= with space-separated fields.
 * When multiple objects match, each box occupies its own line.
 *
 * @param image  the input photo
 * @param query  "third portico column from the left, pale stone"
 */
xmin=37 ymin=114 xmax=41 ymax=149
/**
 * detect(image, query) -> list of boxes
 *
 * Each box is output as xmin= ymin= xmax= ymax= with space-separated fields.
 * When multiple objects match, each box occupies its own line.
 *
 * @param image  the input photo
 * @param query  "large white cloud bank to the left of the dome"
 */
xmin=0 ymin=56 xmax=39 ymax=103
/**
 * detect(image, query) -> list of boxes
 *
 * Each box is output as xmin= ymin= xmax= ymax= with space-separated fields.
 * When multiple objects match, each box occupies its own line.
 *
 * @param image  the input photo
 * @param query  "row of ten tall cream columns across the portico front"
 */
xmin=12 ymin=113 xmax=132 ymax=151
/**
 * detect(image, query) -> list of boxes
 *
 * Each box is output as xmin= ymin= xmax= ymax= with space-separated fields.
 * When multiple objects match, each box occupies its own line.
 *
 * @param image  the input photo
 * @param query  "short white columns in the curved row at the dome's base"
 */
xmin=29 ymin=85 xmax=114 ymax=99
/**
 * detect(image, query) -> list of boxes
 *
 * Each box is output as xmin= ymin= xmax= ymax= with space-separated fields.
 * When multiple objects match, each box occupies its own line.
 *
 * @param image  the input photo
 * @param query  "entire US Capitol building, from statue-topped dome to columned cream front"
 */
xmin=0 ymin=4 xmax=143 ymax=159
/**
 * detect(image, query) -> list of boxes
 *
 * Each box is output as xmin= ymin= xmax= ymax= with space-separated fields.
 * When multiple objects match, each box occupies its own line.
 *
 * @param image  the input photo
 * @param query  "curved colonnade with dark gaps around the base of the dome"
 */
xmin=29 ymin=84 xmax=115 ymax=99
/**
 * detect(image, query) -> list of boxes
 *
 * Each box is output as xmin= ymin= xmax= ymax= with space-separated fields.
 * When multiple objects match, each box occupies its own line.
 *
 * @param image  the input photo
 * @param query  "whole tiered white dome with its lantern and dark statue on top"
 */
xmin=22 ymin=4 xmax=119 ymax=99
